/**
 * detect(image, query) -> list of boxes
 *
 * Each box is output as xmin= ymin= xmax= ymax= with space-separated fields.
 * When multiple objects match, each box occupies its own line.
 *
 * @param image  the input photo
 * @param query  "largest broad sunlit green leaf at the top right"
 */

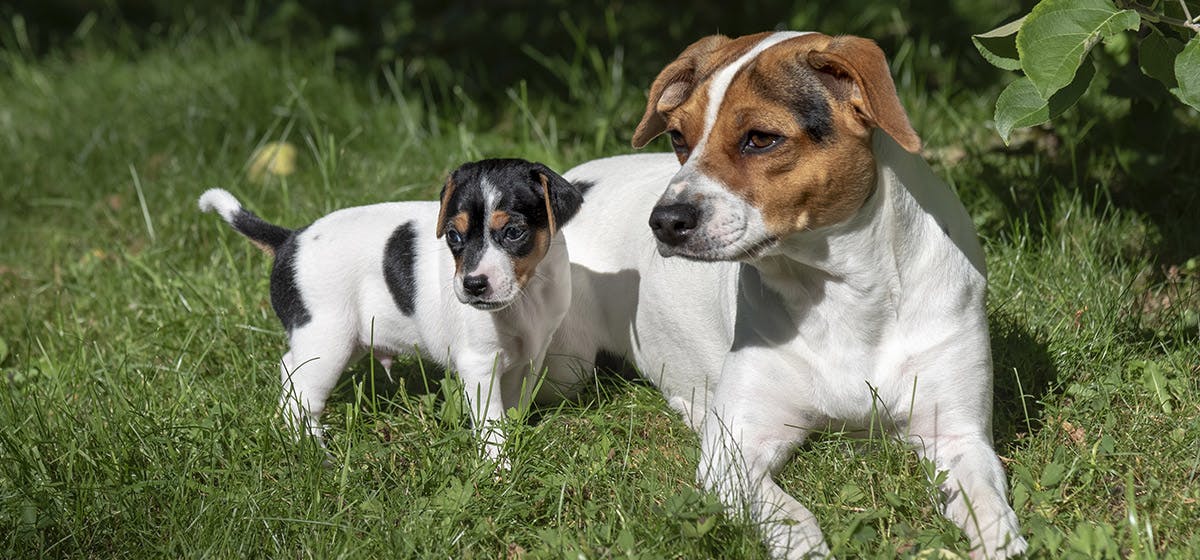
xmin=1016 ymin=0 xmax=1141 ymax=100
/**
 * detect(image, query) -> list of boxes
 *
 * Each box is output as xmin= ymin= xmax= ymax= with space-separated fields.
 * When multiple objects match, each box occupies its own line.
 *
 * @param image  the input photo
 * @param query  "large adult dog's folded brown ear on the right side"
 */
xmin=808 ymin=35 xmax=920 ymax=153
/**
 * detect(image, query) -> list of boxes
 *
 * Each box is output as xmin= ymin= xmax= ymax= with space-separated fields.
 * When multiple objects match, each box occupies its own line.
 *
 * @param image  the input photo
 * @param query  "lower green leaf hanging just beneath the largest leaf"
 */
xmin=996 ymin=56 xmax=1096 ymax=144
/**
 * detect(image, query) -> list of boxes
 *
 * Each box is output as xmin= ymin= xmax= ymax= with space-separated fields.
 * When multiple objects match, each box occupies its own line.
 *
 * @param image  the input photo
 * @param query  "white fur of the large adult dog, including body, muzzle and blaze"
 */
xmin=551 ymin=34 xmax=1026 ymax=558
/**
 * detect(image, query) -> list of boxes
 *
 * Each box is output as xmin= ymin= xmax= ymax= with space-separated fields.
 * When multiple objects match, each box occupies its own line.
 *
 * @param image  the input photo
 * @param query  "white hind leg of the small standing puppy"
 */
xmin=280 ymin=336 xmax=353 ymax=446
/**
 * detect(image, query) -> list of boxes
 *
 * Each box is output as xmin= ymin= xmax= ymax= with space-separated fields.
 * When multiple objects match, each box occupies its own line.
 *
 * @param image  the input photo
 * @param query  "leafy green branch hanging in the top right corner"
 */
xmin=972 ymin=0 xmax=1200 ymax=143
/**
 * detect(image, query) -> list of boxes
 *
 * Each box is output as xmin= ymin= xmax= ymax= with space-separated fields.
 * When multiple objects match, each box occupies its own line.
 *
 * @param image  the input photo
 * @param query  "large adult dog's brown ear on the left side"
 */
xmin=634 ymin=35 xmax=730 ymax=147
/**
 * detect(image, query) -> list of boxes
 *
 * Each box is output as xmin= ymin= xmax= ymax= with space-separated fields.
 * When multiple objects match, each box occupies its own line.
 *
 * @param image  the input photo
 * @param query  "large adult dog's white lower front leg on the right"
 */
xmin=907 ymin=430 xmax=1027 ymax=559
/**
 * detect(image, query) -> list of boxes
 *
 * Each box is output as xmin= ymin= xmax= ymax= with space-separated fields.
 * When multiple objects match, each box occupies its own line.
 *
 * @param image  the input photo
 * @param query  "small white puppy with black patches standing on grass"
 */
xmin=199 ymin=159 xmax=581 ymax=458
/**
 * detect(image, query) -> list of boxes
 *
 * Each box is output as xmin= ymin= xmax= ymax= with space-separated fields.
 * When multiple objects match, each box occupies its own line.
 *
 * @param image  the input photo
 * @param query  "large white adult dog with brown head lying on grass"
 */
xmin=551 ymin=32 xmax=1026 ymax=558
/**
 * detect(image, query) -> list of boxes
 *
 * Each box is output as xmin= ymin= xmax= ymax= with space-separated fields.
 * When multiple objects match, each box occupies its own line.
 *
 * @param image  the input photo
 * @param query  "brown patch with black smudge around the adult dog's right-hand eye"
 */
xmin=697 ymin=35 xmax=875 ymax=237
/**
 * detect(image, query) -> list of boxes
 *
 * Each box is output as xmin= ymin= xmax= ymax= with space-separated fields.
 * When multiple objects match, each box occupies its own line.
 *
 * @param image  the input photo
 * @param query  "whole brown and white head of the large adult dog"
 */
xmin=634 ymin=32 xmax=920 ymax=260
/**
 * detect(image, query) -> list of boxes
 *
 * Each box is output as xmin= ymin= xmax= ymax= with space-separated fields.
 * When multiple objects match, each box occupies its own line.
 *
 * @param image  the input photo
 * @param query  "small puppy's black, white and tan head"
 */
xmin=437 ymin=159 xmax=583 ymax=311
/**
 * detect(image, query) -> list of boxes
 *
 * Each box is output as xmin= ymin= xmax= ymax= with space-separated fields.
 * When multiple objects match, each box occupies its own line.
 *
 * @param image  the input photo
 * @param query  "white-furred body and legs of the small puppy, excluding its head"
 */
xmin=200 ymin=189 xmax=570 ymax=458
